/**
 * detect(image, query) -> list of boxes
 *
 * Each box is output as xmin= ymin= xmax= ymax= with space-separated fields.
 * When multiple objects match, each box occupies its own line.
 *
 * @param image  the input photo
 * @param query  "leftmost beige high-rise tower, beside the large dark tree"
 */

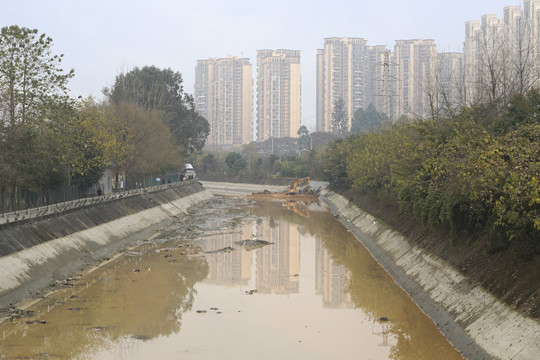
xmin=194 ymin=56 xmax=253 ymax=147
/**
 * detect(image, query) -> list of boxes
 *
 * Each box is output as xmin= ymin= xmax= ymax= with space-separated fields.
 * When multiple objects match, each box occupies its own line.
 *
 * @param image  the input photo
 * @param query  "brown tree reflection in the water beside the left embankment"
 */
xmin=0 ymin=248 xmax=208 ymax=358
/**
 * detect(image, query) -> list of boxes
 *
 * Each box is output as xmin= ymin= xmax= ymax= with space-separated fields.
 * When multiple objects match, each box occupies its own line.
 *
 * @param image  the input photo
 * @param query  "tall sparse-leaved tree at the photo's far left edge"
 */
xmin=0 ymin=25 xmax=74 ymax=190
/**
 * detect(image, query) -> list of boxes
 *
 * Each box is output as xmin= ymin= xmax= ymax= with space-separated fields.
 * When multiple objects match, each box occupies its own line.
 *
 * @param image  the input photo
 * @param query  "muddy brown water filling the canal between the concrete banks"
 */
xmin=0 ymin=198 xmax=461 ymax=360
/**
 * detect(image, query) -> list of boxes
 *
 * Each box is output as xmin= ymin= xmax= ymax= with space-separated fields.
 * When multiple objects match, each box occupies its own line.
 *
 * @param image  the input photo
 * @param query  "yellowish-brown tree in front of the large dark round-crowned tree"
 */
xmin=76 ymin=99 xmax=183 ymax=190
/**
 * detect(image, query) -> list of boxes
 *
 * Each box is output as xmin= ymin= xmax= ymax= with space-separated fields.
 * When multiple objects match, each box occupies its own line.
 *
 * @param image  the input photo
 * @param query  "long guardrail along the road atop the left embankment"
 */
xmin=0 ymin=180 xmax=193 ymax=225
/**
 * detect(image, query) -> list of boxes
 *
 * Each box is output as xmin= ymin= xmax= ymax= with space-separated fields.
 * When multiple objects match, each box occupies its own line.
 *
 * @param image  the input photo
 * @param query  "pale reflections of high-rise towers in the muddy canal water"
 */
xmin=203 ymin=211 xmax=354 ymax=309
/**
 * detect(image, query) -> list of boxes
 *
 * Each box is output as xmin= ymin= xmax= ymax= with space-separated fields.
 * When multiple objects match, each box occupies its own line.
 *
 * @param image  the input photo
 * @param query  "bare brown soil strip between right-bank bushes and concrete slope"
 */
xmin=341 ymin=190 xmax=540 ymax=319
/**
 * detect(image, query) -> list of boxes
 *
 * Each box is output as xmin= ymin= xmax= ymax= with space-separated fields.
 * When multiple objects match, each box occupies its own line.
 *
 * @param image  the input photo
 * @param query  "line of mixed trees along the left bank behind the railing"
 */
xmin=0 ymin=25 xmax=209 ymax=200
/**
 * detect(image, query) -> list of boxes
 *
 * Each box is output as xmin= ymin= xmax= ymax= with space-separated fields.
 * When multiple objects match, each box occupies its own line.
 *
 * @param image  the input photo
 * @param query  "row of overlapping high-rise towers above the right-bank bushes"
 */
xmin=316 ymin=0 xmax=540 ymax=132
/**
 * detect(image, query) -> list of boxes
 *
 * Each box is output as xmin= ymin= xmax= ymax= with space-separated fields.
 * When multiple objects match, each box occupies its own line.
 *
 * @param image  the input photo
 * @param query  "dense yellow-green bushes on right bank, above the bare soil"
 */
xmin=321 ymin=90 xmax=540 ymax=257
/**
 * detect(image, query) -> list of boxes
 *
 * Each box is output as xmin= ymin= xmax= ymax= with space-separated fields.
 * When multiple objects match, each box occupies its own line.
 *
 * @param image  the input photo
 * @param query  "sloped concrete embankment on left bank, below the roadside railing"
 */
xmin=0 ymin=181 xmax=213 ymax=307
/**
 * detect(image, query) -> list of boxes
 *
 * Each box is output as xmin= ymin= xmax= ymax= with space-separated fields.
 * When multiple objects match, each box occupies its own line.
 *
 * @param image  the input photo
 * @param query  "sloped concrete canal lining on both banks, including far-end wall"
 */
xmin=0 ymin=181 xmax=540 ymax=359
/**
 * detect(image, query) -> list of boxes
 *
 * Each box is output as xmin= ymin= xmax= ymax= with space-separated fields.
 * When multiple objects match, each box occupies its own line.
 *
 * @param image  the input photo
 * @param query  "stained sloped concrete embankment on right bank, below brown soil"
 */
xmin=323 ymin=191 xmax=540 ymax=360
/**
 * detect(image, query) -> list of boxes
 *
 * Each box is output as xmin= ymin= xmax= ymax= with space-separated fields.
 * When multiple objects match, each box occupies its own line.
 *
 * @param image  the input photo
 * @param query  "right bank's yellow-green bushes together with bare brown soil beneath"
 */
xmin=321 ymin=91 xmax=540 ymax=317
